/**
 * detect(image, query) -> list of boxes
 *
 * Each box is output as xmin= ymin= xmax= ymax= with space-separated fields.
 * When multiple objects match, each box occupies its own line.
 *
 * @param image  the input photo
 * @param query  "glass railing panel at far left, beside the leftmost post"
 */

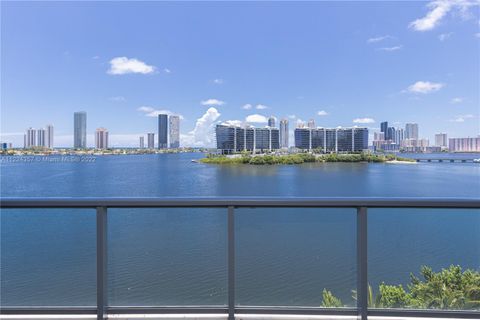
xmin=0 ymin=209 xmax=96 ymax=307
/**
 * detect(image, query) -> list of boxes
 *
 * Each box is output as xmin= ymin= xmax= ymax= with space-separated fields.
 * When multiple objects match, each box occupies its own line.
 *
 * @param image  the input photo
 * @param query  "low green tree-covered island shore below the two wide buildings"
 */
xmin=199 ymin=152 xmax=416 ymax=165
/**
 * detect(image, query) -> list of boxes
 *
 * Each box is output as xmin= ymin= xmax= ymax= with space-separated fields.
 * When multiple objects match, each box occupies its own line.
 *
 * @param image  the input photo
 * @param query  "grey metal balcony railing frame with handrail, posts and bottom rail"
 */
xmin=1 ymin=198 xmax=480 ymax=320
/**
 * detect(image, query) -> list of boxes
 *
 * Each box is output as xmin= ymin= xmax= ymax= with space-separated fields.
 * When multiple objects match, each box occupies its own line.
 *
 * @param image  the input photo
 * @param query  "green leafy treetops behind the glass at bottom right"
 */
xmin=322 ymin=265 xmax=480 ymax=310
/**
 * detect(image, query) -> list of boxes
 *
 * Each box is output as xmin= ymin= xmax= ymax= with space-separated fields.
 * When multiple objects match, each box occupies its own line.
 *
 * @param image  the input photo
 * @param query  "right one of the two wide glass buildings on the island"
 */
xmin=295 ymin=128 xmax=368 ymax=152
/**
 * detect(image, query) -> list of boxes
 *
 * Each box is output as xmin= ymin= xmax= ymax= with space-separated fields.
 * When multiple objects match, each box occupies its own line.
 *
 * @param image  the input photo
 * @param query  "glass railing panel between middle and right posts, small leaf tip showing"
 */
xmin=235 ymin=208 xmax=356 ymax=307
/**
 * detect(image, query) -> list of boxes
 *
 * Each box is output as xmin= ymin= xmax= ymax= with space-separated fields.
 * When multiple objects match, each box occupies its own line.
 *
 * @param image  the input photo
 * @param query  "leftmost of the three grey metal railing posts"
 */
xmin=97 ymin=207 xmax=107 ymax=320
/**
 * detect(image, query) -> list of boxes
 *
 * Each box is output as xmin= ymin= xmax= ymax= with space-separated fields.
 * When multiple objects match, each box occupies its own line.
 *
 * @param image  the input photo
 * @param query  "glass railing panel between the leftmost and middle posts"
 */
xmin=108 ymin=208 xmax=227 ymax=306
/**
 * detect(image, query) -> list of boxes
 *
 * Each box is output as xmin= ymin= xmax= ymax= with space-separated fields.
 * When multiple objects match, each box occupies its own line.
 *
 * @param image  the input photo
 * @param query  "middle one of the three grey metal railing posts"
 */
xmin=227 ymin=206 xmax=235 ymax=320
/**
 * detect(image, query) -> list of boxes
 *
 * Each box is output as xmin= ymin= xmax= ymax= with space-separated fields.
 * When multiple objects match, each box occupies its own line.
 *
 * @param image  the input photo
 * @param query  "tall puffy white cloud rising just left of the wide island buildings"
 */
xmin=180 ymin=107 xmax=220 ymax=147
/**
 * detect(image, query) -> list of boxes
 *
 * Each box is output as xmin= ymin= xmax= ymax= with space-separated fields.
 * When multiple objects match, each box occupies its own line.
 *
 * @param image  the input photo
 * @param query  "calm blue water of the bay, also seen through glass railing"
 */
xmin=0 ymin=154 xmax=480 ymax=306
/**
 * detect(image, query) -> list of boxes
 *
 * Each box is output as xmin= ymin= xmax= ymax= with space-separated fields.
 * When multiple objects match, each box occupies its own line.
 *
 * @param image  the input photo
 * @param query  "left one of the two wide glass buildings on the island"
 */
xmin=215 ymin=124 xmax=280 ymax=154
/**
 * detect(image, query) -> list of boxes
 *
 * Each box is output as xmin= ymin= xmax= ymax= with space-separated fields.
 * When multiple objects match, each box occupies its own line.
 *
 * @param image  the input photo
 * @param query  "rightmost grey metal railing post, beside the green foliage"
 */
xmin=357 ymin=207 xmax=368 ymax=320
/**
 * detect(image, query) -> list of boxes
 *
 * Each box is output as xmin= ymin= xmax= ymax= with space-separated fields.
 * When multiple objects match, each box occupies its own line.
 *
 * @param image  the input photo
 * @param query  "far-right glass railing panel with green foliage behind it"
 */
xmin=368 ymin=209 xmax=480 ymax=310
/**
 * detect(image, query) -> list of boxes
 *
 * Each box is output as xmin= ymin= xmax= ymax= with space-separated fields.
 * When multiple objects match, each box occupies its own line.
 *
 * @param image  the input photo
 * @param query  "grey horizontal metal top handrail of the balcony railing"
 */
xmin=0 ymin=197 xmax=480 ymax=208
